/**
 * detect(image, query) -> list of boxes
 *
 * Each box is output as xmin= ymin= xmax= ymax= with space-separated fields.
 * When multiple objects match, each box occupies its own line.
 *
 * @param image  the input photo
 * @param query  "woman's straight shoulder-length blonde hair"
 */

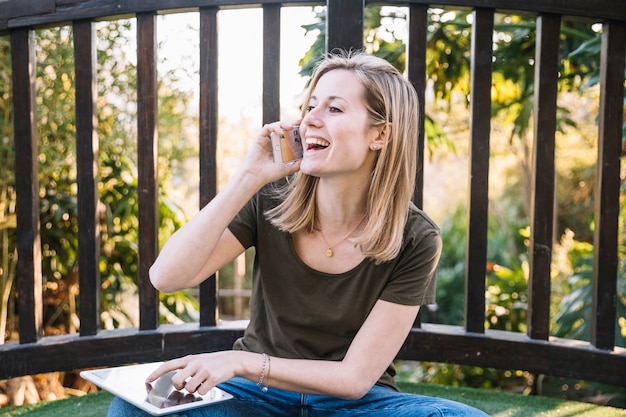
xmin=265 ymin=52 xmax=419 ymax=264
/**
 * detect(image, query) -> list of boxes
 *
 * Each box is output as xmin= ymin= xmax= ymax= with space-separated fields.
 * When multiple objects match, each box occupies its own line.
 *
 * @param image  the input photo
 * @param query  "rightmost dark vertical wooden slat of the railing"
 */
xmin=591 ymin=22 xmax=626 ymax=349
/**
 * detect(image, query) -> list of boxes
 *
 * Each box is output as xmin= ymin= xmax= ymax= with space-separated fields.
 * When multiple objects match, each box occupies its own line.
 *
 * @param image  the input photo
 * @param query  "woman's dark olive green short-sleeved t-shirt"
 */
xmin=229 ymin=187 xmax=441 ymax=389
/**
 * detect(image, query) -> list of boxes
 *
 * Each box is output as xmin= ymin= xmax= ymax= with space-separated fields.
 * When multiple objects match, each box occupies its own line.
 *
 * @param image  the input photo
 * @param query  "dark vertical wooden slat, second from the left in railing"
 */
xmin=74 ymin=20 xmax=100 ymax=336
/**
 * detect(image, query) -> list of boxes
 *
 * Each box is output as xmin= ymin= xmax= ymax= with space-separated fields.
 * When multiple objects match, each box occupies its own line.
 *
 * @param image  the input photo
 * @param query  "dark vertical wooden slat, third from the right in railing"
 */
xmin=465 ymin=9 xmax=494 ymax=333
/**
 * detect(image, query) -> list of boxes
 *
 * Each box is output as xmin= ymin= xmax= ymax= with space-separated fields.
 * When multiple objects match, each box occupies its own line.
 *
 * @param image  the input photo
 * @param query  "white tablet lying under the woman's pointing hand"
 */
xmin=80 ymin=362 xmax=232 ymax=416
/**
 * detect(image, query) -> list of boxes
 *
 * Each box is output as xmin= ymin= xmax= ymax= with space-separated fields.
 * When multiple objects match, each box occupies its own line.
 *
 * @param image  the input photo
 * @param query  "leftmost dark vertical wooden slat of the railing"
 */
xmin=11 ymin=29 xmax=43 ymax=343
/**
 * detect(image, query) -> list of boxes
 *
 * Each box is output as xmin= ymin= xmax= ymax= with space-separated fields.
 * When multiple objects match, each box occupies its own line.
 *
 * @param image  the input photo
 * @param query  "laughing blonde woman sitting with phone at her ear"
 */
xmin=109 ymin=53 xmax=485 ymax=416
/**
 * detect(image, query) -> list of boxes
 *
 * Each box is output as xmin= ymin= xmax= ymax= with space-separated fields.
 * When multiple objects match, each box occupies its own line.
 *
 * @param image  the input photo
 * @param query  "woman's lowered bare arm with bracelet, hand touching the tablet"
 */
xmin=148 ymin=300 xmax=419 ymax=399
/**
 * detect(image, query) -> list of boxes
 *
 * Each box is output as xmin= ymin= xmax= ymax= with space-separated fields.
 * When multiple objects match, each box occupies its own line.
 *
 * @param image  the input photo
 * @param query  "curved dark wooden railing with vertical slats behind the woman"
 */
xmin=0 ymin=0 xmax=626 ymax=386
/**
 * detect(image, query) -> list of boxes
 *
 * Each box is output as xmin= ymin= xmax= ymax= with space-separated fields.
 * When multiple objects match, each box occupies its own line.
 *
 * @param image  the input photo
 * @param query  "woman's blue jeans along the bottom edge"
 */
xmin=107 ymin=378 xmax=487 ymax=417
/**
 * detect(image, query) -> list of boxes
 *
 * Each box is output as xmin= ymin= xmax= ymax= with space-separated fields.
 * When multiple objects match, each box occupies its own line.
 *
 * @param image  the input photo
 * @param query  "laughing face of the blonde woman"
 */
xmin=300 ymin=69 xmax=379 ymax=178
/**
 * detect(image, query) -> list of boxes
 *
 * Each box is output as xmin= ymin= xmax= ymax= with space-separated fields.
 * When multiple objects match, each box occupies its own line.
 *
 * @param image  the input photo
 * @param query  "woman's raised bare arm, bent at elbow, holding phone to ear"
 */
xmin=150 ymin=123 xmax=300 ymax=292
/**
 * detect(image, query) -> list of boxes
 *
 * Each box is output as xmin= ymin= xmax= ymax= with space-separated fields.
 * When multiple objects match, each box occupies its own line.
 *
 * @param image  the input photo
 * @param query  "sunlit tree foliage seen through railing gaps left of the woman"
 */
xmin=0 ymin=20 xmax=197 ymax=337
